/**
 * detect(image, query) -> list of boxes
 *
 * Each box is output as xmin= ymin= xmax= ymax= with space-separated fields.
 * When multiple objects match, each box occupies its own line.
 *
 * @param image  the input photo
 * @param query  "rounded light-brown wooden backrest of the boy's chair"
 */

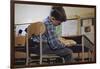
xmin=27 ymin=22 xmax=45 ymax=38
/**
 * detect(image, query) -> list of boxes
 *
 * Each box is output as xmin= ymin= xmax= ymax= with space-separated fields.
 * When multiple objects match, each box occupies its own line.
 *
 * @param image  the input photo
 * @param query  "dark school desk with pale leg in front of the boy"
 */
xmin=63 ymin=35 xmax=93 ymax=62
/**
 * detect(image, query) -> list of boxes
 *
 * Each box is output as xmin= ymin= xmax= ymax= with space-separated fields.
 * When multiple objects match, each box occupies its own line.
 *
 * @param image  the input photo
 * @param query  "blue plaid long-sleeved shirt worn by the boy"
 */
xmin=32 ymin=17 xmax=65 ymax=50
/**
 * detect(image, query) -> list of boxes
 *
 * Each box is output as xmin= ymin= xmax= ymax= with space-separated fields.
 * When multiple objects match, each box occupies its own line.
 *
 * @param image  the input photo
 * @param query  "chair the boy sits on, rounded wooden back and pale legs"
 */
xmin=26 ymin=22 xmax=64 ymax=65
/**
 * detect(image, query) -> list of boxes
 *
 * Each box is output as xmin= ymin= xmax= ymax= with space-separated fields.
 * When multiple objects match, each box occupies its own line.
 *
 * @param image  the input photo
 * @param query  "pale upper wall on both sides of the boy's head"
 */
xmin=15 ymin=4 xmax=94 ymax=24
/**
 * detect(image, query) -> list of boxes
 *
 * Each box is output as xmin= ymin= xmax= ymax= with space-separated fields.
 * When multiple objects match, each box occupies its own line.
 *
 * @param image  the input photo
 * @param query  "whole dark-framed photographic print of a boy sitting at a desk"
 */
xmin=11 ymin=0 xmax=96 ymax=68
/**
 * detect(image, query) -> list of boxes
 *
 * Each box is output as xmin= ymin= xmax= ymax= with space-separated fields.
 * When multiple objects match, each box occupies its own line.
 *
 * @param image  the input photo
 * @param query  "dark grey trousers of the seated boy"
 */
xmin=31 ymin=45 xmax=73 ymax=63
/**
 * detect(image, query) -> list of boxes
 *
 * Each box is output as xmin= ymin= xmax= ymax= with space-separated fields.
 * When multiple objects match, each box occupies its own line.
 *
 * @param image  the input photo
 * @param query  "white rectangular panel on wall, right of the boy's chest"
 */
xmin=62 ymin=20 xmax=78 ymax=36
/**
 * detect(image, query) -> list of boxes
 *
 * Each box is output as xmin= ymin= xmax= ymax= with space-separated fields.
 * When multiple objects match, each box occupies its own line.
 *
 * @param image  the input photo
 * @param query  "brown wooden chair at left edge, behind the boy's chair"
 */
xmin=15 ymin=36 xmax=26 ymax=65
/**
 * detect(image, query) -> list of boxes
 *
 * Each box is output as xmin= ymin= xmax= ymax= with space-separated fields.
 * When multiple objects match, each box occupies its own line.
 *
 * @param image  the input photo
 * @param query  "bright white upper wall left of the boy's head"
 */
xmin=15 ymin=4 xmax=51 ymax=24
